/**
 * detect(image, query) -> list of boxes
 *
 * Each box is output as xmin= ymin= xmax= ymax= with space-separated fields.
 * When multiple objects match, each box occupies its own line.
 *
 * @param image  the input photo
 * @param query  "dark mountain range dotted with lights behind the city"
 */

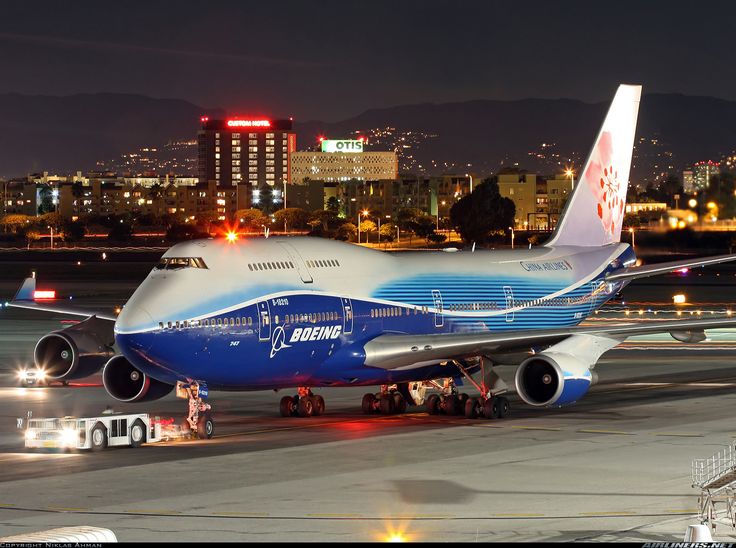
xmin=0 ymin=93 xmax=736 ymax=179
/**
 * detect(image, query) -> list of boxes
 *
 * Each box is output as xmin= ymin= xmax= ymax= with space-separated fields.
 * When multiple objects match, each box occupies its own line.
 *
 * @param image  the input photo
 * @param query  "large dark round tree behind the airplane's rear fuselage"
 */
xmin=450 ymin=177 xmax=516 ymax=244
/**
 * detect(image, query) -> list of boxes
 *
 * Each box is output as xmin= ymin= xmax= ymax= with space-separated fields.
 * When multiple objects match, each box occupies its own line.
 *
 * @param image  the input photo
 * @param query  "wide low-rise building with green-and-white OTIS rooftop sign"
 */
xmin=289 ymin=139 xmax=399 ymax=183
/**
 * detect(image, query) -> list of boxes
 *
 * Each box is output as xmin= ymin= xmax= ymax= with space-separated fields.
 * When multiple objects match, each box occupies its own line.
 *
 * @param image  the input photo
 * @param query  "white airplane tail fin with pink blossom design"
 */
xmin=545 ymin=84 xmax=641 ymax=247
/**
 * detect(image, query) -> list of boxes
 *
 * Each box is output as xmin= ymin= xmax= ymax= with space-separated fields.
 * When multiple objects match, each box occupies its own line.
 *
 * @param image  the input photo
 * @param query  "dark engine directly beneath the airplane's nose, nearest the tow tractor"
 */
xmin=102 ymin=355 xmax=174 ymax=403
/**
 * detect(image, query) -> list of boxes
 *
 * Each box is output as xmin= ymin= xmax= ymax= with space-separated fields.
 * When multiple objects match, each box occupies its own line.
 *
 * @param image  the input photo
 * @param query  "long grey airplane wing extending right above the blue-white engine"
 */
xmin=364 ymin=317 xmax=736 ymax=369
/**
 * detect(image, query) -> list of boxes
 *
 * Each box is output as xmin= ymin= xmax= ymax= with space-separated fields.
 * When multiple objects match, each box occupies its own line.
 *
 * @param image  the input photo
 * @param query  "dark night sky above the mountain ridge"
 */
xmin=0 ymin=0 xmax=736 ymax=121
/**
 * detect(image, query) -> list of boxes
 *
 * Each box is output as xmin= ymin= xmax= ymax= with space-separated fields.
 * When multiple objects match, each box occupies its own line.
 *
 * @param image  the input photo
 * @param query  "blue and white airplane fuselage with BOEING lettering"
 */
xmin=115 ymin=238 xmax=635 ymax=390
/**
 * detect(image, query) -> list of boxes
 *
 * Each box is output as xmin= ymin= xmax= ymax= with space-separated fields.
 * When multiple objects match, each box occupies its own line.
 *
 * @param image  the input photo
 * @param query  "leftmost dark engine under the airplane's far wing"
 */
xmin=33 ymin=316 xmax=115 ymax=381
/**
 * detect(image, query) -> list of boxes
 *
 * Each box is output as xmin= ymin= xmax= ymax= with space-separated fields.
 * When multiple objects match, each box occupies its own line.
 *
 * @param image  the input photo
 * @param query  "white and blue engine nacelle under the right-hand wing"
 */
xmin=515 ymin=352 xmax=598 ymax=407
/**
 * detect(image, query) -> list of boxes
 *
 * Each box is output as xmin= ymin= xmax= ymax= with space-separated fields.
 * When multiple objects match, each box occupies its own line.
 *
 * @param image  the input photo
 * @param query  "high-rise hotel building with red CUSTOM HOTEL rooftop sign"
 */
xmin=197 ymin=116 xmax=296 ymax=194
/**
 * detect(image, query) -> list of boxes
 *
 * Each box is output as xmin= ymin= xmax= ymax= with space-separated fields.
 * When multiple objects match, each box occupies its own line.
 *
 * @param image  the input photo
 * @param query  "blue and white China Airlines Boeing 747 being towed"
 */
xmin=10 ymin=85 xmax=736 ymax=436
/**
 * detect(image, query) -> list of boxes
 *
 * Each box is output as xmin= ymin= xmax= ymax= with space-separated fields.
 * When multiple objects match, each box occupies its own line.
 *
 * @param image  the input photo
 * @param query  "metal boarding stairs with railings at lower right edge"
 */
xmin=692 ymin=444 xmax=736 ymax=530
